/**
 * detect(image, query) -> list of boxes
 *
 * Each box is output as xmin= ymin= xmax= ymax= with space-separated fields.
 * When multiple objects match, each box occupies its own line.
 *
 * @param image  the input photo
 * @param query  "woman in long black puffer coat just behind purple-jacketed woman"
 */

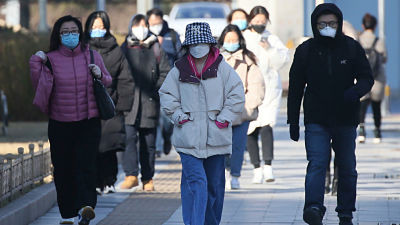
xmin=85 ymin=11 xmax=135 ymax=193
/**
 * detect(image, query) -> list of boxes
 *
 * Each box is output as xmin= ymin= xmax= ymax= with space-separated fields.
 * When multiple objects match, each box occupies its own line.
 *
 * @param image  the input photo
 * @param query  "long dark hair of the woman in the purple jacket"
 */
xmin=49 ymin=15 xmax=86 ymax=52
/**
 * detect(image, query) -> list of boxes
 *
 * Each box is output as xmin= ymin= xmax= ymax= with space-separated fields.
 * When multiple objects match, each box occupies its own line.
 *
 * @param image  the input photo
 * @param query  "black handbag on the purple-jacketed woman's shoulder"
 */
xmin=90 ymin=50 xmax=115 ymax=120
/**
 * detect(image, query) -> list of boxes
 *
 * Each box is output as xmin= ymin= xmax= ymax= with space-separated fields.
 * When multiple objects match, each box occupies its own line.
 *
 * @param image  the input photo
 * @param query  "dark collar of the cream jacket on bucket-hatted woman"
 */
xmin=175 ymin=54 xmax=224 ymax=84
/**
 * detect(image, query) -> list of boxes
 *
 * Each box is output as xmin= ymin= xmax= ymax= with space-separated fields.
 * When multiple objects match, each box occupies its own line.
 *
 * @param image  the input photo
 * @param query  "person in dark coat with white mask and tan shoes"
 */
xmin=121 ymin=14 xmax=170 ymax=191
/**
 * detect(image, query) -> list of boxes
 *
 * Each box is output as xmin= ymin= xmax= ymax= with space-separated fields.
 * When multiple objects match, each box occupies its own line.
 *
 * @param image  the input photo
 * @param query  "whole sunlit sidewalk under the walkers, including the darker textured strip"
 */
xmin=32 ymin=114 xmax=400 ymax=225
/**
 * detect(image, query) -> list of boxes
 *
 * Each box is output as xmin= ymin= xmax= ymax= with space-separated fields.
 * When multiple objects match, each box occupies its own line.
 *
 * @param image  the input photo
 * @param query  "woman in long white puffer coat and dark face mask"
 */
xmin=243 ymin=6 xmax=289 ymax=183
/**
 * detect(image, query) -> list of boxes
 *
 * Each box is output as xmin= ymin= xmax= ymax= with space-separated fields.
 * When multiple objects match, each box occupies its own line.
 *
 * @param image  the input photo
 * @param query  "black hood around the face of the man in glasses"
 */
xmin=311 ymin=3 xmax=343 ymax=43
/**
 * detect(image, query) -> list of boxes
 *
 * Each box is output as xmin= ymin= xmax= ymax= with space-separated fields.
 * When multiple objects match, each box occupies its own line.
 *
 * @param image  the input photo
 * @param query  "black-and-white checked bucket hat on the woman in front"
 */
xmin=182 ymin=22 xmax=217 ymax=46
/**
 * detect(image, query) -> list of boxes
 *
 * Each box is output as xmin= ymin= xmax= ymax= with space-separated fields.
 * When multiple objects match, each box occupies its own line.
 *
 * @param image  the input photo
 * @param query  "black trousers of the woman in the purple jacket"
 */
xmin=48 ymin=118 xmax=101 ymax=218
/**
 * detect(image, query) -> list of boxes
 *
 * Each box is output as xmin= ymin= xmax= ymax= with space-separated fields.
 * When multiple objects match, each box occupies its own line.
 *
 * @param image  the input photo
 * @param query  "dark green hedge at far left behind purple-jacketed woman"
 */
xmin=0 ymin=31 xmax=49 ymax=121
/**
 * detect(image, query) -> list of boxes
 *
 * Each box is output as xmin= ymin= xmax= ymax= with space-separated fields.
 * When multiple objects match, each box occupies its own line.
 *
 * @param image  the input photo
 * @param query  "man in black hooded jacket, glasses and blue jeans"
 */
xmin=287 ymin=3 xmax=374 ymax=225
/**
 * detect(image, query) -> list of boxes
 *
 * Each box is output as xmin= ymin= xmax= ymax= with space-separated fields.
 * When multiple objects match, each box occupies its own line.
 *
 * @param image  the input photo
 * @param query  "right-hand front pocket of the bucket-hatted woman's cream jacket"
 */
xmin=207 ymin=112 xmax=232 ymax=147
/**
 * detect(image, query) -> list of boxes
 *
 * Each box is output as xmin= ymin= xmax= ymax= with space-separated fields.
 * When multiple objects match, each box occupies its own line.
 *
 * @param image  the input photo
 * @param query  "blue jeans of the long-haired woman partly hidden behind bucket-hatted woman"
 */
xmin=225 ymin=121 xmax=250 ymax=177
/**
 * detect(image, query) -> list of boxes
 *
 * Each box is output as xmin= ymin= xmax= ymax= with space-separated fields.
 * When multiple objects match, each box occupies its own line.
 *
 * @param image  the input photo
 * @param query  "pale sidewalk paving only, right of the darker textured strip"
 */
xmin=164 ymin=115 xmax=400 ymax=225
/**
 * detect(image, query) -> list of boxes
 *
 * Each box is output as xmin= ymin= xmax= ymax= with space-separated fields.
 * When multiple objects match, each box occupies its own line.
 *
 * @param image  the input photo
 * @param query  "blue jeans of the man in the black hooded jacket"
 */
xmin=304 ymin=124 xmax=357 ymax=216
